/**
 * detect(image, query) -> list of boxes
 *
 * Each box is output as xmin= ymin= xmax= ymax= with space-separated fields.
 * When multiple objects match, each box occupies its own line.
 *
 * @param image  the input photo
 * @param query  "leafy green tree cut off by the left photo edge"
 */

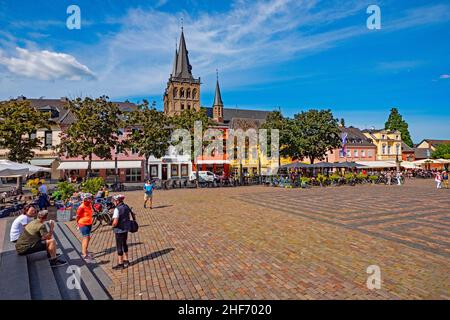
xmin=0 ymin=100 xmax=51 ymax=163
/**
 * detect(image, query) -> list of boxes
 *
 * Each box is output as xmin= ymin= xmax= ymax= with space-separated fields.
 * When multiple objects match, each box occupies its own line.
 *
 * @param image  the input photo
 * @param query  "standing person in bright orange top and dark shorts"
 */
xmin=77 ymin=193 xmax=94 ymax=263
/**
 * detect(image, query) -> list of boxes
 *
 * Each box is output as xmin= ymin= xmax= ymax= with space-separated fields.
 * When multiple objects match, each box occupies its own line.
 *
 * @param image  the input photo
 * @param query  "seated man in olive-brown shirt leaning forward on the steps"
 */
xmin=16 ymin=210 xmax=67 ymax=267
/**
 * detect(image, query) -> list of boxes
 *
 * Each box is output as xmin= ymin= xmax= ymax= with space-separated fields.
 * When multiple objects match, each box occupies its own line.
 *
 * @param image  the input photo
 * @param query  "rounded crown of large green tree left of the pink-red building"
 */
xmin=281 ymin=110 xmax=341 ymax=163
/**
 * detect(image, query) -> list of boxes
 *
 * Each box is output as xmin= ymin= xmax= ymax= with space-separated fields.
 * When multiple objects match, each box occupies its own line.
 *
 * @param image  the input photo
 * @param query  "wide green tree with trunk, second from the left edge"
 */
xmin=58 ymin=96 xmax=125 ymax=177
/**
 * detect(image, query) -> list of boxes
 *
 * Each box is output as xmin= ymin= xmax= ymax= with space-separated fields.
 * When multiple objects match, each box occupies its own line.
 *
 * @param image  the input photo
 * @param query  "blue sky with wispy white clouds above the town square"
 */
xmin=0 ymin=0 xmax=450 ymax=142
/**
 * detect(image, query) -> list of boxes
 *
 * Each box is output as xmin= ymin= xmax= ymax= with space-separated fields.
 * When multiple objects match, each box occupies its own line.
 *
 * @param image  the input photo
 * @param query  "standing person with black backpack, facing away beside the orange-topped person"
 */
xmin=112 ymin=194 xmax=136 ymax=270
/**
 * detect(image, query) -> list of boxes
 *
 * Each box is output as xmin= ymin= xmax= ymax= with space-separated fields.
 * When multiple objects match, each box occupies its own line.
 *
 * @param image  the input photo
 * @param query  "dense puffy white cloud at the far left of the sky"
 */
xmin=0 ymin=48 xmax=95 ymax=80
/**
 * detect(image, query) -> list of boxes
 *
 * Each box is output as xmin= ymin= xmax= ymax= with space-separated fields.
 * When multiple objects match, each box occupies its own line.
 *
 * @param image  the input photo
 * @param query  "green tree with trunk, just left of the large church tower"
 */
xmin=127 ymin=100 xmax=170 ymax=178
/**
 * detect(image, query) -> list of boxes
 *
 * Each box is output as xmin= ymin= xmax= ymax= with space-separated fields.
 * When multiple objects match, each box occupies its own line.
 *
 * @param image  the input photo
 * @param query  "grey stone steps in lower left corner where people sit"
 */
xmin=0 ymin=218 xmax=111 ymax=300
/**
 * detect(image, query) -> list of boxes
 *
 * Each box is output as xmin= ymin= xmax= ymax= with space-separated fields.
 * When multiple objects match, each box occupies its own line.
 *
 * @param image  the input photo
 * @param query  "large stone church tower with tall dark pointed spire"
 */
xmin=164 ymin=28 xmax=200 ymax=116
